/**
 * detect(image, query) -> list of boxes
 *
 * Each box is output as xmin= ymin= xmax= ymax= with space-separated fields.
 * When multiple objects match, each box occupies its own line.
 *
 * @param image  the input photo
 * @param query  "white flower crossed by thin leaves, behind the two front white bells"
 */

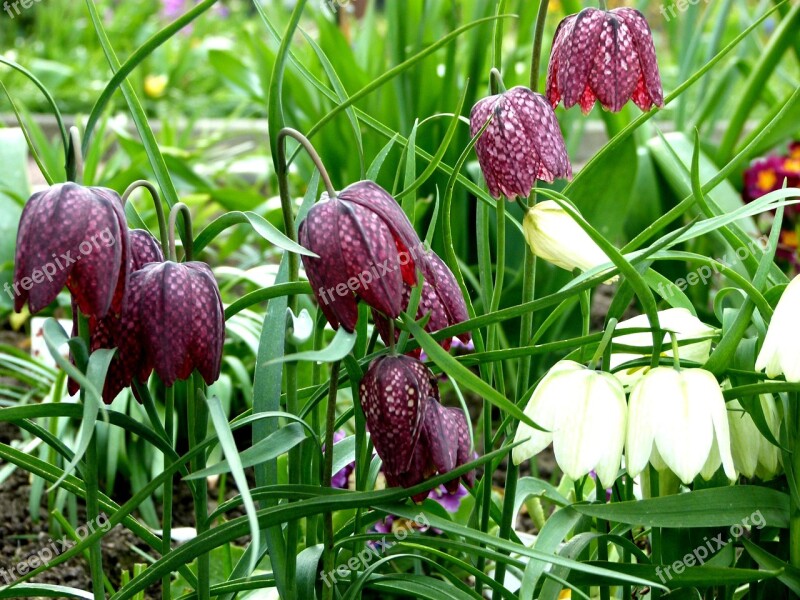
xmin=609 ymin=308 xmax=717 ymax=389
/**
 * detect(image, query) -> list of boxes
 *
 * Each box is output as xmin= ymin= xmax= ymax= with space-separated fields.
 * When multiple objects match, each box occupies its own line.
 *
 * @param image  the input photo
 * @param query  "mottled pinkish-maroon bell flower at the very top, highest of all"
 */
xmin=547 ymin=8 xmax=664 ymax=113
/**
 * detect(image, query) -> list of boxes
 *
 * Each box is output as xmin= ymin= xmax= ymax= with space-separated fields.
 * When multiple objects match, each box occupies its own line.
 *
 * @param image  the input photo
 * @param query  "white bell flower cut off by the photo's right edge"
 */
xmin=756 ymin=275 xmax=800 ymax=383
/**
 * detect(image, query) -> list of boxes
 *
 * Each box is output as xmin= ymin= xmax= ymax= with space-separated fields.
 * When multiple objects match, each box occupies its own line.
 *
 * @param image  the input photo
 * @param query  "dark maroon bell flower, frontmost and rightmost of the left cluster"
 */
xmin=129 ymin=261 xmax=225 ymax=386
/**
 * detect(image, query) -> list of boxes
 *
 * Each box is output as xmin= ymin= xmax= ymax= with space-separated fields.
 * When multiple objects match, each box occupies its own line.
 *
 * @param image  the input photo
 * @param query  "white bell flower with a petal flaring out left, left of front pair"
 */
xmin=511 ymin=360 xmax=628 ymax=488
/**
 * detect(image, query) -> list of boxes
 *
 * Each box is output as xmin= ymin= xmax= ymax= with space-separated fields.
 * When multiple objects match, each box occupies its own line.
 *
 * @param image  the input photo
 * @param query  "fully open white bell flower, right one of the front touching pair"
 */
xmin=626 ymin=367 xmax=736 ymax=485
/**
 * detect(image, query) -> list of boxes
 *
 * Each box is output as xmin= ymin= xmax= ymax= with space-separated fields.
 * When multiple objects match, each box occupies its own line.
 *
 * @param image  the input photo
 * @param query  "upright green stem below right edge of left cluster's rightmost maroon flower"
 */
xmin=188 ymin=378 xmax=211 ymax=600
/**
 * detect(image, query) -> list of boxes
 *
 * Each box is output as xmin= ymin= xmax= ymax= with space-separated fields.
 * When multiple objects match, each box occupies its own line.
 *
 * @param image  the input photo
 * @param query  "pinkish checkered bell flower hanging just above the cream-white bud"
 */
xmin=470 ymin=87 xmax=572 ymax=200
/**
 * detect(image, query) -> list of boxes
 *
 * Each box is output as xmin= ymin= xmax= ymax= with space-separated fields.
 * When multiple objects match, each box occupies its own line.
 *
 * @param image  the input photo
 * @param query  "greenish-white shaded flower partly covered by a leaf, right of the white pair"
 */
xmin=728 ymin=394 xmax=781 ymax=481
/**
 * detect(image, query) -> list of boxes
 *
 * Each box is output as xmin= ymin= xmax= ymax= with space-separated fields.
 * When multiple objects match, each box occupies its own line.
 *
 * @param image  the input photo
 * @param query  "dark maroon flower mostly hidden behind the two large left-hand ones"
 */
xmin=69 ymin=229 xmax=164 ymax=404
